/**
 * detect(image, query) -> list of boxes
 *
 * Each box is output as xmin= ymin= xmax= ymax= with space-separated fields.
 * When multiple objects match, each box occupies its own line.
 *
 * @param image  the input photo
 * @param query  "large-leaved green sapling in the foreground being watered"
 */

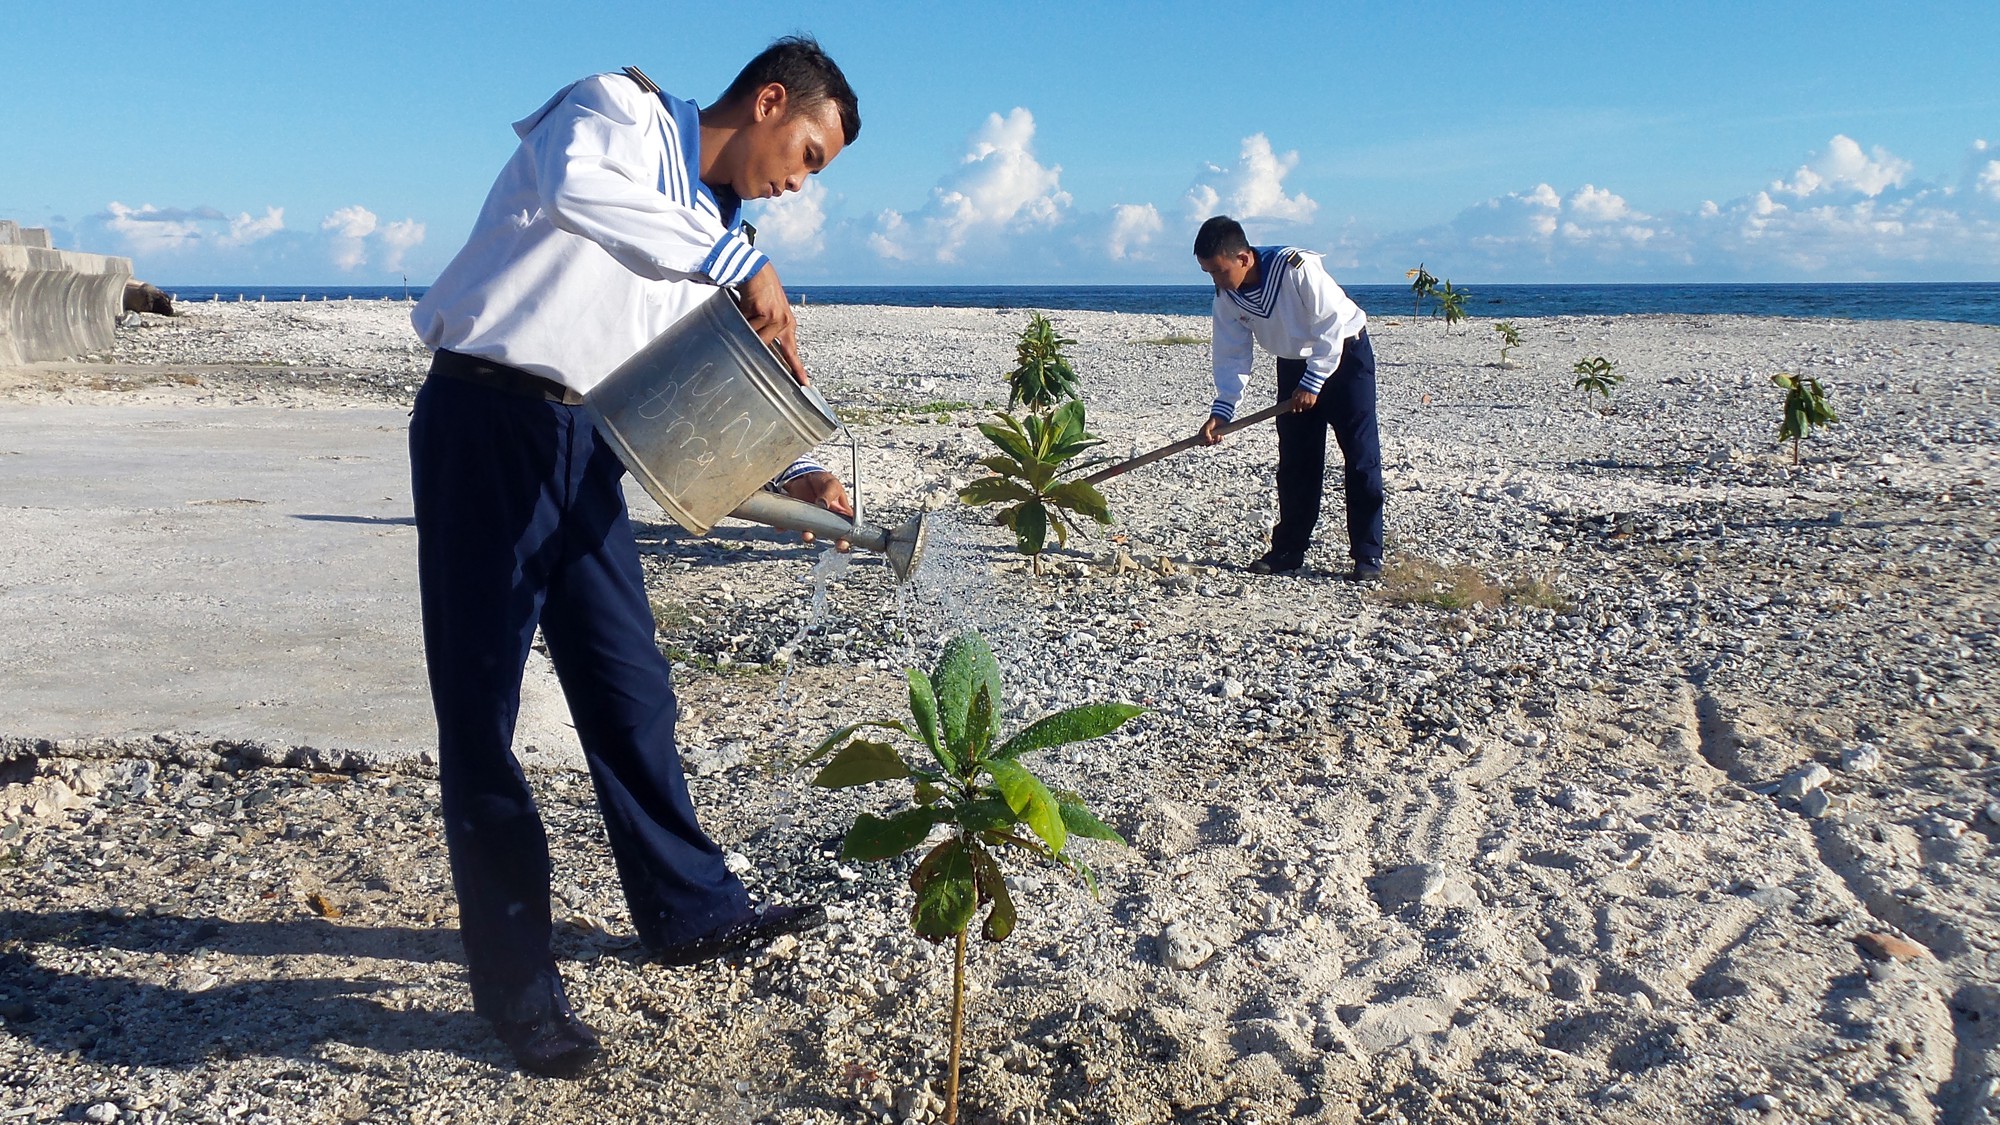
xmin=812 ymin=631 xmax=1144 ymax=1125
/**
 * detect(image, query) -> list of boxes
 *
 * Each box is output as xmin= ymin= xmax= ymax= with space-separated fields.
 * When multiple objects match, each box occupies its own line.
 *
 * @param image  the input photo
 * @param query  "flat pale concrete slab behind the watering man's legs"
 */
xmin=0 ymin=404 xmax=580 ymax=765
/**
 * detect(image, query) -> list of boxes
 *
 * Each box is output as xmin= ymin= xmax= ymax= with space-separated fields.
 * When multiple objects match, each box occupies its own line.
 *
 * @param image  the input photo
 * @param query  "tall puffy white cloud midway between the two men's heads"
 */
xmin=868 ymin=106 xmax=1070 ymax=262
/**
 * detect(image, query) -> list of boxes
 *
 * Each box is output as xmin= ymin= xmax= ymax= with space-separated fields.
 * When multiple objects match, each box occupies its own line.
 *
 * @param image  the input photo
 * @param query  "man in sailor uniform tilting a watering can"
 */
xmin=410 ymin=38 xmax=860 ymax=1077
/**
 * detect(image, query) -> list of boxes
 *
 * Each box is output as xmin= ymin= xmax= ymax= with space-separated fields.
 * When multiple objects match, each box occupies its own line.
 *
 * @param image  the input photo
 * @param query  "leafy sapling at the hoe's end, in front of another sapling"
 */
xmin=958 ymin=400 xmax=1112 ymax=575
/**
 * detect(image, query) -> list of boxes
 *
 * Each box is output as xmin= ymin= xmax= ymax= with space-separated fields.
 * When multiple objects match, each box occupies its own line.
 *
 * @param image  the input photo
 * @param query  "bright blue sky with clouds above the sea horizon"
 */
xmin=0 ymin=0 xmax=2000 ymax=286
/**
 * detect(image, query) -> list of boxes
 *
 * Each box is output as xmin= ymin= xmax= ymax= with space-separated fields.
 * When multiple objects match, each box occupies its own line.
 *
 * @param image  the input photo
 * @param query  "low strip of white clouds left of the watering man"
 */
xmin=64 ymin=200 xmax=424 ymax=280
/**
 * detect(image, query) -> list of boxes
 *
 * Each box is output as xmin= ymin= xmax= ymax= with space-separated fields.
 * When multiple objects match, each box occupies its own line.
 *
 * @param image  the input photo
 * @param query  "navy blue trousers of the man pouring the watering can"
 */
xmin=410 ymin=374 xmax=750 ymax=1021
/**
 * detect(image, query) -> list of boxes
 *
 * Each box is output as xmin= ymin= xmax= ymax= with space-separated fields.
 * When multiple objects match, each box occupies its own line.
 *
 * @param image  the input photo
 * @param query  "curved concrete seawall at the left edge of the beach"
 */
xmin=0 ymin=222 xmax=132 ymax=364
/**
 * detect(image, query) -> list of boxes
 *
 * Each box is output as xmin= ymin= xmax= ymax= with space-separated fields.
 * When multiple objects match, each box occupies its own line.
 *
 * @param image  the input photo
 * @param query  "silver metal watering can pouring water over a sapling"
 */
xmin=584 ymin=290 xmax=924 ymax=583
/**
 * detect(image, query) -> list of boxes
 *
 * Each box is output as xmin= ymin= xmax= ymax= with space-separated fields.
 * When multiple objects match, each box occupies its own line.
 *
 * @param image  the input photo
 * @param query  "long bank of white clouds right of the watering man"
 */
xmin=758 ymin=116 xmax=2000 ymax=282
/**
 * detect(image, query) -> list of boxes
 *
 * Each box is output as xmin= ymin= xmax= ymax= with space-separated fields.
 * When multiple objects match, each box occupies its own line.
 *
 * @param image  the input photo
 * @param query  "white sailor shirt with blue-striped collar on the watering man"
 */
xmin=410 ymin=74 xmax=766 ymax=392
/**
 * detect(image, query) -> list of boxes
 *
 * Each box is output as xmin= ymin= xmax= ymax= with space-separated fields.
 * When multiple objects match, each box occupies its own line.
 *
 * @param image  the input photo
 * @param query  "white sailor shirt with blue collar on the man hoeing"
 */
xmin=1208 ymin=246 xmax=1368 ymax=422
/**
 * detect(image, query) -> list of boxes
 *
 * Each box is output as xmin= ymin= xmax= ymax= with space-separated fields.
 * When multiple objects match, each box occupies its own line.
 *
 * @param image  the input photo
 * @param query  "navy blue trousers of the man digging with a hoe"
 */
xmin=1270 ymin=332 xmax=1382 ymax=563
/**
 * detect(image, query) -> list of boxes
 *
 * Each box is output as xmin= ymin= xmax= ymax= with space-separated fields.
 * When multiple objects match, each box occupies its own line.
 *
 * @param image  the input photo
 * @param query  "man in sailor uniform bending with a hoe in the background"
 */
xmin=1194 ymin=214 xmax=1382 ymax=581
